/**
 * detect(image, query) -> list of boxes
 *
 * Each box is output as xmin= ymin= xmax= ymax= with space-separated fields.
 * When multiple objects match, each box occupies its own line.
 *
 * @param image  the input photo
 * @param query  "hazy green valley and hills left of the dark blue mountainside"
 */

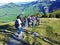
xmin=0 ymin=2 xmax=43 ymax=21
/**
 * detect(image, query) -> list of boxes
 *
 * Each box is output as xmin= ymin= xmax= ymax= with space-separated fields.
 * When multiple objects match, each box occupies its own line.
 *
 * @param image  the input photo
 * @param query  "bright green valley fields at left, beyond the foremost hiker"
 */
xmin=0 ymin=7 xmax=21 ymax=21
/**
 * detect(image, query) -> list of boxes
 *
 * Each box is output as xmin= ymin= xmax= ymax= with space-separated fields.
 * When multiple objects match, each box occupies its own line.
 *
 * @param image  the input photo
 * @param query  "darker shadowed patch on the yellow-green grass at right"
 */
xmin=46 ymin=26 xmax=60 ymax=44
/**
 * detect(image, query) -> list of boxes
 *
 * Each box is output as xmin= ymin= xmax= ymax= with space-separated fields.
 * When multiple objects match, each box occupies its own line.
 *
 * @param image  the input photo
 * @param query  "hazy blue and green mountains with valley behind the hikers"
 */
xmin=0 ymin=0 xmax=60 ymax=19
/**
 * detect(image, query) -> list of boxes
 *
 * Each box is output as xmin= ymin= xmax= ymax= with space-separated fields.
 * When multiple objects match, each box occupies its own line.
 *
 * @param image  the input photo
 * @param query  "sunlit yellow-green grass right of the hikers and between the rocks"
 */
xmin=0 ymin=18 xmax=60 ymax=45
